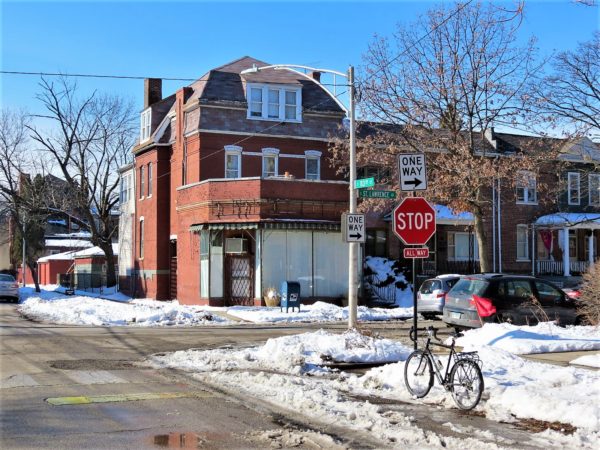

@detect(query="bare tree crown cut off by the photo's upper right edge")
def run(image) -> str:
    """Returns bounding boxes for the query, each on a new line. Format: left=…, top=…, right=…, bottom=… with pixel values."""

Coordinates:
left=537, top=31, right=600, bottom=133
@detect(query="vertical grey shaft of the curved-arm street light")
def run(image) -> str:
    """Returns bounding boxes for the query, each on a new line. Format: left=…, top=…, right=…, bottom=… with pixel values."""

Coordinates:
left=348, top=66, right=358, bottom=328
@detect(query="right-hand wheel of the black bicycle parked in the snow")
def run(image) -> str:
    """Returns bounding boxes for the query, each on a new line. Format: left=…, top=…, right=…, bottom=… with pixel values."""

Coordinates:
left=450, top=359, right=483, bottom=411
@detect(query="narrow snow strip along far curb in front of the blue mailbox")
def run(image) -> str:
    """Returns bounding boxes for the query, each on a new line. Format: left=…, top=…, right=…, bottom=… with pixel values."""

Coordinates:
left=227, top=302, right=412, bottom=323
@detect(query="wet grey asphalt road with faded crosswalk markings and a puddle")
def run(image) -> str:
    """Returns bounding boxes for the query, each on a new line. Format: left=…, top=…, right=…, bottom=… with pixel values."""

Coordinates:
left=0, top=302, right=552, bottom=449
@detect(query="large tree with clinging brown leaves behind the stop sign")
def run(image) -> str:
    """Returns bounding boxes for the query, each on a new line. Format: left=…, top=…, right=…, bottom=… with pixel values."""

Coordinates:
left=334, top=2, right=568, bottom=271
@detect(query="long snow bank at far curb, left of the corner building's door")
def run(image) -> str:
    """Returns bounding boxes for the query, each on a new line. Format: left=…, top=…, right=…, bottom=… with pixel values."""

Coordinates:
left=19, top=291, right=231, bottom=327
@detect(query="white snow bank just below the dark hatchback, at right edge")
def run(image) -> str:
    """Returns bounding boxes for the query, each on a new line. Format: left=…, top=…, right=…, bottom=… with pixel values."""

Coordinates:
left=456, top=322, right=600, bottom=355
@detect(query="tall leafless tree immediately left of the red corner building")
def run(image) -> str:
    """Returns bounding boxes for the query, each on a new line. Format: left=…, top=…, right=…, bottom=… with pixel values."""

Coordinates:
left=28, top=78, right=135, bottom=287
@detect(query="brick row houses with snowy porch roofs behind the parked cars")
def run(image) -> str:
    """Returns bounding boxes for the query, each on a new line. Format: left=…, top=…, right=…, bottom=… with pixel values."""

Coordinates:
left=359, top=130, right=600, bottom=277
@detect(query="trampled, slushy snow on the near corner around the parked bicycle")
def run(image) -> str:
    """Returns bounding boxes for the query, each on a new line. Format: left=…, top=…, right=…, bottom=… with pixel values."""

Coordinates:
left=150, top=325, right=600, bottom=449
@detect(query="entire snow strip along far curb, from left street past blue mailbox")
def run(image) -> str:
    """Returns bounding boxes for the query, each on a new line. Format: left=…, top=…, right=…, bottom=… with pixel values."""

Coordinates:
left=20, top=286, right=412, bottom=326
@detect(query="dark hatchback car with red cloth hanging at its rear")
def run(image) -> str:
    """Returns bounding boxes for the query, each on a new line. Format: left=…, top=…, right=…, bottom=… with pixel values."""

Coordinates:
left=442, top=274, right=579, bottom=328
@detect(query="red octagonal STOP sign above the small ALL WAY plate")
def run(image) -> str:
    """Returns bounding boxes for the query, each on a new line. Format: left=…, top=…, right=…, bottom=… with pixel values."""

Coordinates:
left=394, top=197, right=435, bottom=245
